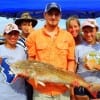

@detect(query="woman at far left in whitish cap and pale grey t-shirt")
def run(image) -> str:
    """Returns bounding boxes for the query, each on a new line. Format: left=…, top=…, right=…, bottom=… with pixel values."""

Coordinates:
left=0, top=23, right=26, bottom=100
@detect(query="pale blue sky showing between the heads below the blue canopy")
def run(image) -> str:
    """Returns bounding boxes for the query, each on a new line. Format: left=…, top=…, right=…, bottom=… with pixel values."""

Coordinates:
left=0, top=17, right=100, bottom=35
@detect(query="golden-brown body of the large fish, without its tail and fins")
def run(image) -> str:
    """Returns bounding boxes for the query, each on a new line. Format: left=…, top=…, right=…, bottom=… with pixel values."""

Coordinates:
left=11, top=60, right=90, bottom=87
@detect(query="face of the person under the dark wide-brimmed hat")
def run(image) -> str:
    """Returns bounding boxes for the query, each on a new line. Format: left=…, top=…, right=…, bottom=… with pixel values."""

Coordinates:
left=20, top=21, right=32, bottom=35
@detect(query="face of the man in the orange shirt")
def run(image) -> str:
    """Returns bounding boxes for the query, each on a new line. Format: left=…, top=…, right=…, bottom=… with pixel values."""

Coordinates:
left=44, top=9, right=61, bottom=27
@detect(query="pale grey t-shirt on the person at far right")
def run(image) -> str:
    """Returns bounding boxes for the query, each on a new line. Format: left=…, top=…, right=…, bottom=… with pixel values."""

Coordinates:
left=75, top=42, right=100, bottom=83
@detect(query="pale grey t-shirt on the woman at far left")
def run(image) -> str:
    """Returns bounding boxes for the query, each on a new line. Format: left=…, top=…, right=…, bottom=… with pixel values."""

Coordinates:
left=0, top=45, right=26, bottom=100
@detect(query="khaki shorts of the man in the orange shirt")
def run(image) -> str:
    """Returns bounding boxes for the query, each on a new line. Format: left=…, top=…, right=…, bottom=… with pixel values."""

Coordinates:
left=33, top=90, right=70, bottom=100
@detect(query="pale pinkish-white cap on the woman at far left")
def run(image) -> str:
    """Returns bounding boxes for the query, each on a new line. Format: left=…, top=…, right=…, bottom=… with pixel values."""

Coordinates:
left=4, top=23, right=20, bottom=34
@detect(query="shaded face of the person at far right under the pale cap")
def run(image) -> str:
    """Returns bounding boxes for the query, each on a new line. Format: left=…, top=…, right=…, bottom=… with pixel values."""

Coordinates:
left=83, top=26, right=97, bottom=44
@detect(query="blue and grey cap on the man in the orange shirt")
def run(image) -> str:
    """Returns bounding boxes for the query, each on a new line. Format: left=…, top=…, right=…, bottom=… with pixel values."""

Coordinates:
left=45, top=2, right=61, bottom=12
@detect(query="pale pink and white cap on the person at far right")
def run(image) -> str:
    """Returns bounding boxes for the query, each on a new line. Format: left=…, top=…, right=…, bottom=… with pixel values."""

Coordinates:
left=82, top=19, right=99, bottom=29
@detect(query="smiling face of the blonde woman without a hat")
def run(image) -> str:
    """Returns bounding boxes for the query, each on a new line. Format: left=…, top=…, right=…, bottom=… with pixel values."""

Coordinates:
left=68, top=20, right=80, bottom=37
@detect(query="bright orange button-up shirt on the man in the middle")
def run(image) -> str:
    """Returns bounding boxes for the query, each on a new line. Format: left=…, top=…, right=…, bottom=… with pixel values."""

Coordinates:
left=26, top=27, right=75, bottom=95
